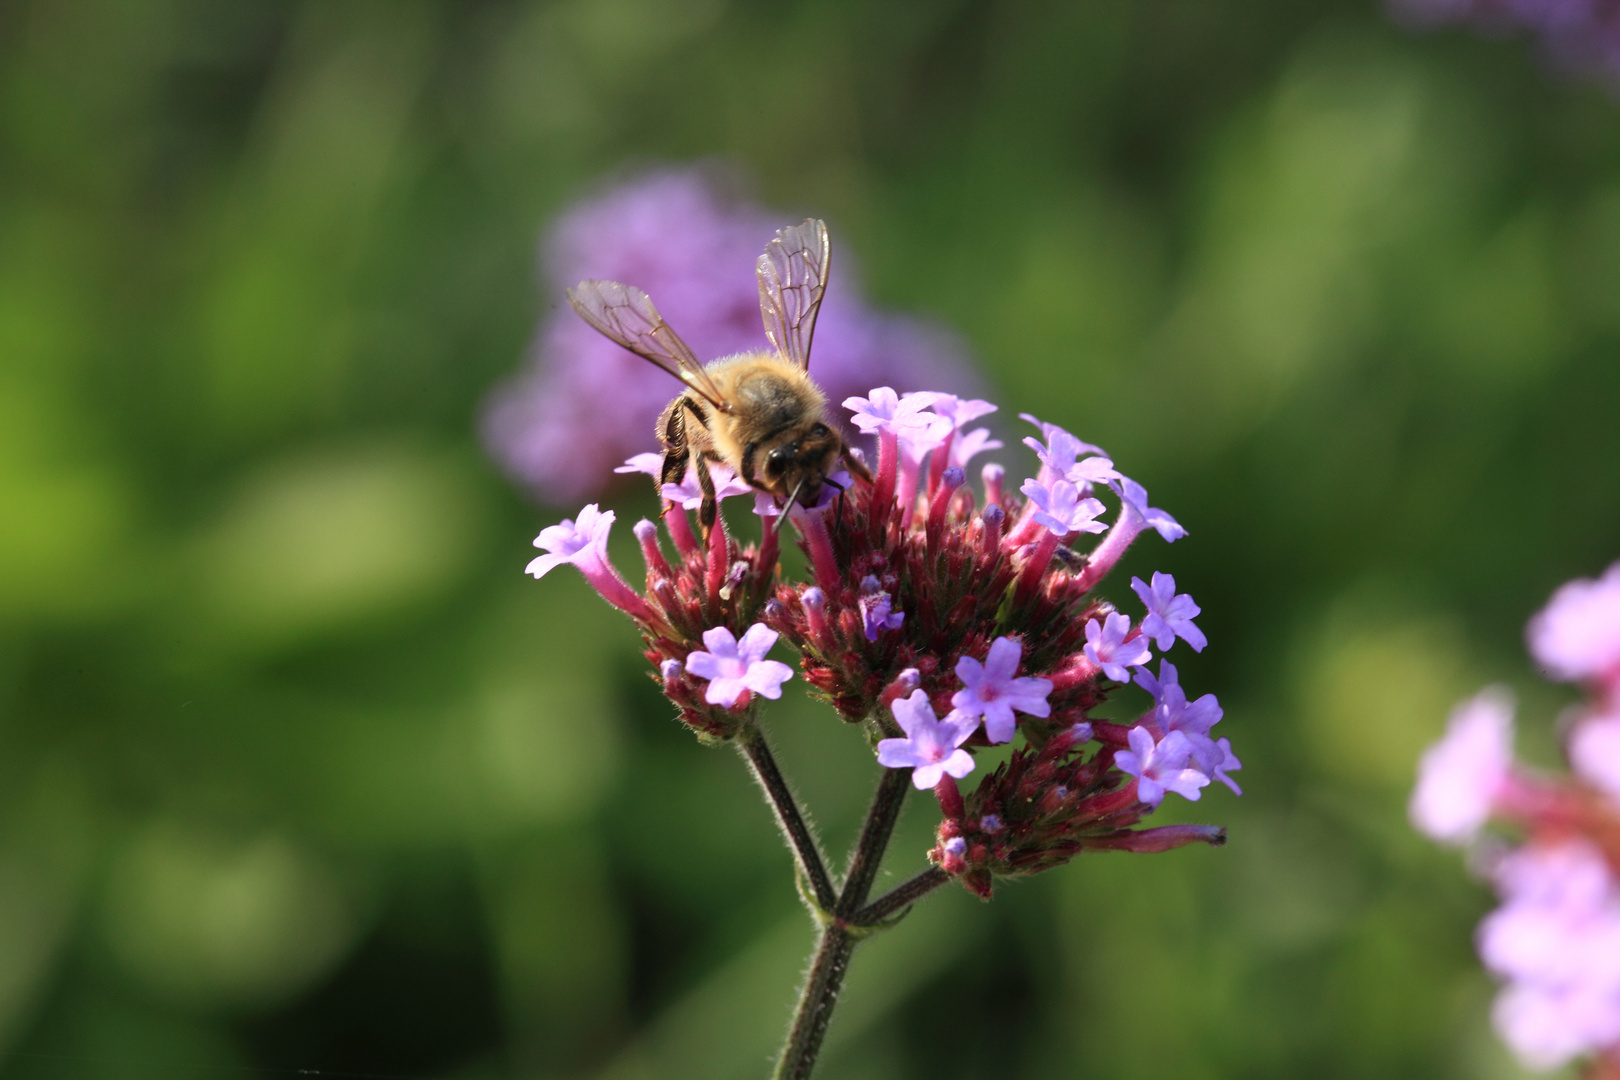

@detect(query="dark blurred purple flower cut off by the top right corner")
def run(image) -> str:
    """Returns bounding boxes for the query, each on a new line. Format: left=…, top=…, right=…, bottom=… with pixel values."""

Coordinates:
left=1390, top=0, right=1620, bottom=89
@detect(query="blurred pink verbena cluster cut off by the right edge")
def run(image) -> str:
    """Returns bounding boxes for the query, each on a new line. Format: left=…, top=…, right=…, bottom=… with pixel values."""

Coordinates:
left=1411, top=563, right=1620, bottom=1077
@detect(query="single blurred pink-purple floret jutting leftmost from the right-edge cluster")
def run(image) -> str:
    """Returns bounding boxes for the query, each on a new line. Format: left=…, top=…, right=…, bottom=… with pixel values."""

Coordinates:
left=1406, top=687, right=1513, bottom=844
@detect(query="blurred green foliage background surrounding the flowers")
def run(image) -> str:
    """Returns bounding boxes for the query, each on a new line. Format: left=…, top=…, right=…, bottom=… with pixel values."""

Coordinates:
left=0, top=0, right=1620, bottom=1080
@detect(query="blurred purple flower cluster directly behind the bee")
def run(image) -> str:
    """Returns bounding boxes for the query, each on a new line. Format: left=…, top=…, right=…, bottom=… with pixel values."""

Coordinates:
left=483, top=167, right=977, bottom=502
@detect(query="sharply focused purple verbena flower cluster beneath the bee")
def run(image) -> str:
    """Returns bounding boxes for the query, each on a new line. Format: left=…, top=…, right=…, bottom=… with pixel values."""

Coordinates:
left=528, top=388, right=1241, bottom=897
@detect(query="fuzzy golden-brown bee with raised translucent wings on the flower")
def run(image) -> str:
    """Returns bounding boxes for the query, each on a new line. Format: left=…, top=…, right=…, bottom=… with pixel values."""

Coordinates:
left=569, top=219, right=872, bottom=534
